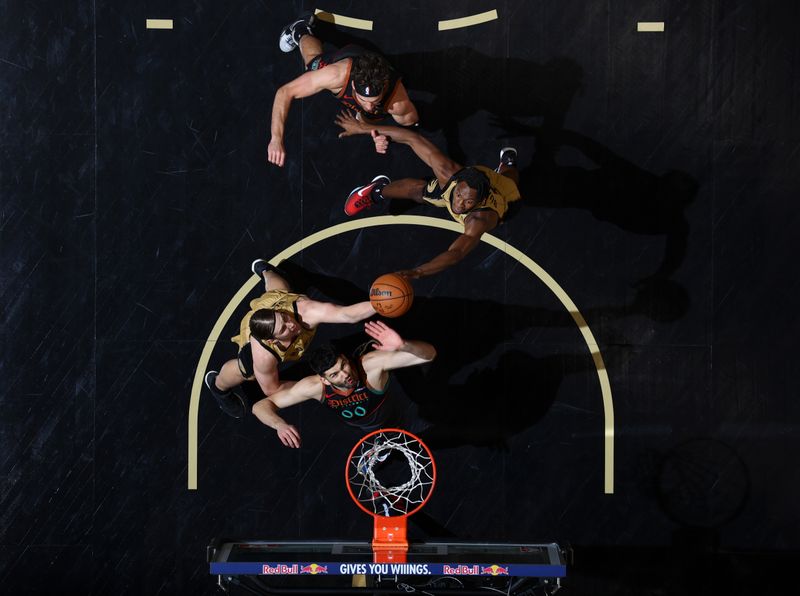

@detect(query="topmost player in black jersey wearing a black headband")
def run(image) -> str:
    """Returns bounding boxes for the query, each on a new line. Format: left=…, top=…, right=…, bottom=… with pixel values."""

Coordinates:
left=267, top=15, right=419, bottom=167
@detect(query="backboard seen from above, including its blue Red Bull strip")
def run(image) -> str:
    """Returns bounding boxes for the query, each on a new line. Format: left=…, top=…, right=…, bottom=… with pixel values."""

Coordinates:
left=207, top=540, right=566, bottom=594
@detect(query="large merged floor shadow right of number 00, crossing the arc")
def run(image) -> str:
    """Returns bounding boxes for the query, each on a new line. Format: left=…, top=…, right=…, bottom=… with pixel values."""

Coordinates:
left=396, top=280, right=690, bottom=448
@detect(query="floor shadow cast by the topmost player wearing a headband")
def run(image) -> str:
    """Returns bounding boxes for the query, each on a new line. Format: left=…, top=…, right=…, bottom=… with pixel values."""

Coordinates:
left=306, top=21, right=583, bottom=163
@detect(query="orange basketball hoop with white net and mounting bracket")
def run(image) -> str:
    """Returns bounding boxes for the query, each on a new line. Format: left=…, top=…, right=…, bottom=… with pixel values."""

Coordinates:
left=345, top=428, right=436, bottom=563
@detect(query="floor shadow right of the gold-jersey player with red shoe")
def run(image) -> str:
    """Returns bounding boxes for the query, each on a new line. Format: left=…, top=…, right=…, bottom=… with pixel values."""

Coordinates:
left=490, top=119, right=699, bottom=283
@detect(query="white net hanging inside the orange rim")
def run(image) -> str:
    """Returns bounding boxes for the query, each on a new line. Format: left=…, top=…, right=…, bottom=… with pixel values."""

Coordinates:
left=347, top=431, right=434, bottom=517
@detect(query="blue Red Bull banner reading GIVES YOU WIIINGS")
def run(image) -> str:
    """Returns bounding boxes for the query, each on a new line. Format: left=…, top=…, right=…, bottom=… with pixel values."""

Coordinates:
left=210, top=561, right=567, bottom=577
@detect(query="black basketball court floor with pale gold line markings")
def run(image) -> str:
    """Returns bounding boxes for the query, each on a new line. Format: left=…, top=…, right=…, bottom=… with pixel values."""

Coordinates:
left=0, top=0, right=800, bottom=595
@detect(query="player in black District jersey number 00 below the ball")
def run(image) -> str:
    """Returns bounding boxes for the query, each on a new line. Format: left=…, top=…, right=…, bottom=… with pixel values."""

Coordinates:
left=253, top=321, right=436, bottom=448
